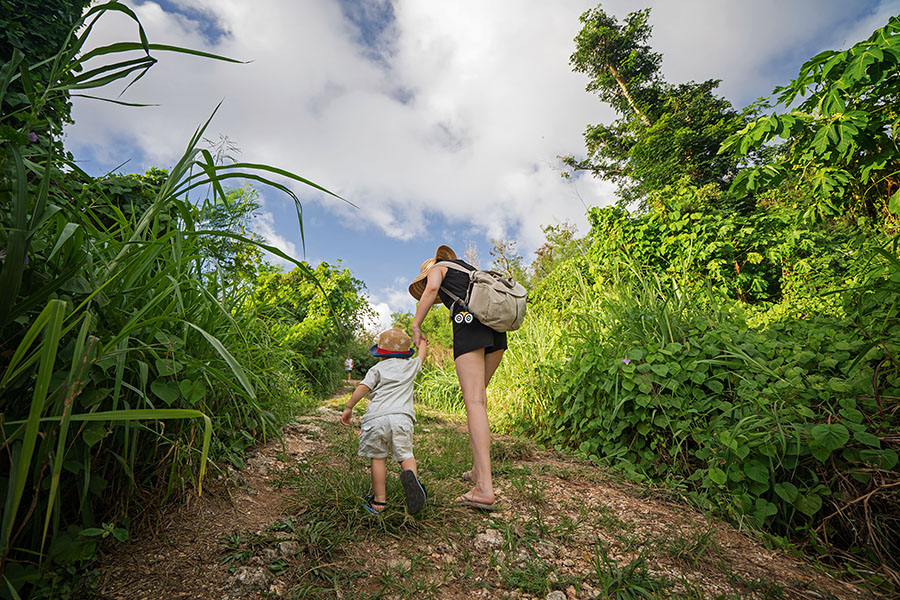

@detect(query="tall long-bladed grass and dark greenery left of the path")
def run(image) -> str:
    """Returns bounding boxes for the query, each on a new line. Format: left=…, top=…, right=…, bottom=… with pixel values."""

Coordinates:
left=0, top=2, right=348, bottom=596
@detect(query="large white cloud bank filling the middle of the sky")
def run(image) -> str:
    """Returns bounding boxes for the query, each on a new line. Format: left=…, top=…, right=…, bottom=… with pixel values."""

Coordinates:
left=70, top=0, right=610, bottom=251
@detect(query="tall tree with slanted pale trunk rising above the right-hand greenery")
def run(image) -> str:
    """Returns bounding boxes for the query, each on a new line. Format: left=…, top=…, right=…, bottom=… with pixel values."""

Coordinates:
left=563, top=6, right=745, bottom=205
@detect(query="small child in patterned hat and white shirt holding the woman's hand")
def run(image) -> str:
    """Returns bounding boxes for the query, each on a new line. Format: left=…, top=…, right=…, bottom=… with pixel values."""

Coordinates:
left=341, top=329, right=428, bottom=514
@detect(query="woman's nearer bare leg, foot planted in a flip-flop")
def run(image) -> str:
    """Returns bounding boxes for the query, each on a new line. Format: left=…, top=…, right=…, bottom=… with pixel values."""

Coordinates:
left=456, top=348, right=494, bottom=504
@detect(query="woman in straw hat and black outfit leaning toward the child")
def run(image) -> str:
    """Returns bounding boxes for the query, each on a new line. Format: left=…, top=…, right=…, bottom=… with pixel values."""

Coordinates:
left=409, top=246, right=506, bottom=510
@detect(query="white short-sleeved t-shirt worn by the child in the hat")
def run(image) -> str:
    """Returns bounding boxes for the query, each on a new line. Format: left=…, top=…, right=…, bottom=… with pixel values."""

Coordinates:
left=359, top=356, right=422, bottom=423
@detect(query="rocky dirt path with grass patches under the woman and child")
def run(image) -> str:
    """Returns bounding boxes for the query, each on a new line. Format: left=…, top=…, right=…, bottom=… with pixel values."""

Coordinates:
left=100, top=390, right=877, bottom=600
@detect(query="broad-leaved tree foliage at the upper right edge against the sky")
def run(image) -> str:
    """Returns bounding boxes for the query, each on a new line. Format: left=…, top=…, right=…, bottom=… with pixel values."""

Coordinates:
left=721, top=17, right=900, bottom=219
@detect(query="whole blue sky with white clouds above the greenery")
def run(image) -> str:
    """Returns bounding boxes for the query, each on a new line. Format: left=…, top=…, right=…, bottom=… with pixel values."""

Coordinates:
left=66, top=0, right=900, bottom=330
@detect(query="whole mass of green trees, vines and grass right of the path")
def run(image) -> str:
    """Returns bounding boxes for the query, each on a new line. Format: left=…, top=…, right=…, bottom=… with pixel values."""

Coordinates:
left=419, top=4, right=900, bottom=593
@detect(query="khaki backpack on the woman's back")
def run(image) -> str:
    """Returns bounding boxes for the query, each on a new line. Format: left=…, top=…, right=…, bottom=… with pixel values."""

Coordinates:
left=434, top=261, right=528, bottom=332
